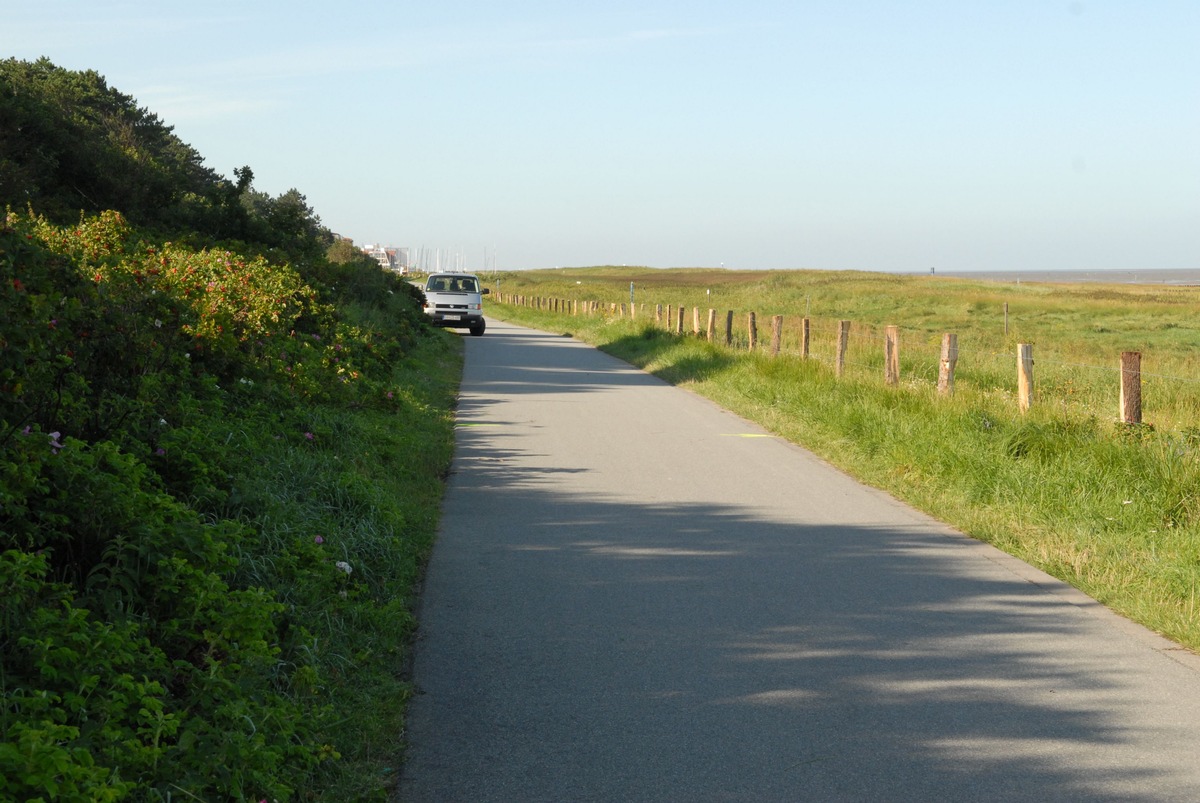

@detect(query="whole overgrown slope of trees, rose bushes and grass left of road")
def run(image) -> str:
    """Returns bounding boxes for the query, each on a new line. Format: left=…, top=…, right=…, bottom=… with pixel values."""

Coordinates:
left=0, top=60, right=461, bottom=802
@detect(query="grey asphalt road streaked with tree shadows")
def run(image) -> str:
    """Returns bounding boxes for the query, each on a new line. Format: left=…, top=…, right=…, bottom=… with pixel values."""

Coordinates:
left=400, top=322, right=1200, bottom=802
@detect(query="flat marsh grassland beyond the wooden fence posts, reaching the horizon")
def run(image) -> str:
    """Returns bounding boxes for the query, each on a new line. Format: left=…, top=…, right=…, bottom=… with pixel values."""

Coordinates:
left=482, top=268, right=1200, bottom=430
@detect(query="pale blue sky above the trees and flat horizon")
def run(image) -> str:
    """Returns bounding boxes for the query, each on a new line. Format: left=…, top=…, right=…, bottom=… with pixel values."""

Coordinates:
left=0, top=0, right=1200, bottom=271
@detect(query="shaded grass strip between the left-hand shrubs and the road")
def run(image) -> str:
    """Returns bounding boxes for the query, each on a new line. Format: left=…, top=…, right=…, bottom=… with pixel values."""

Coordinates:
left=225, top=332, right=462, bottom=801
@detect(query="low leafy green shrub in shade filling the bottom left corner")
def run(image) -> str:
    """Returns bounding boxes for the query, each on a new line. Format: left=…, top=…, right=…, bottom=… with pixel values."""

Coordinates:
left=0, top=433, right=316, bottom=799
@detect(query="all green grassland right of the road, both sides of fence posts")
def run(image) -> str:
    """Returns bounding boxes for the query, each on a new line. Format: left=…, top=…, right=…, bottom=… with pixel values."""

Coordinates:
left=487, top=268, right=1200, bottom=651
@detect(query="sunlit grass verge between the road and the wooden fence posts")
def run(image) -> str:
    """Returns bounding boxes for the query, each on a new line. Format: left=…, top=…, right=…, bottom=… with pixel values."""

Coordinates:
left=491, top=297, right=1200, bottom=651
